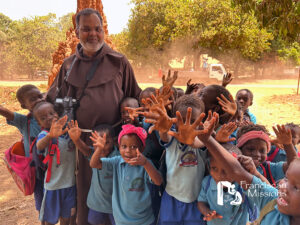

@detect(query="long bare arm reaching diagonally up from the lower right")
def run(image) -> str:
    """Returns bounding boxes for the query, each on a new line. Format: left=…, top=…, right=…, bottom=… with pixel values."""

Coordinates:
left=198, top=113, right=253, bottom=190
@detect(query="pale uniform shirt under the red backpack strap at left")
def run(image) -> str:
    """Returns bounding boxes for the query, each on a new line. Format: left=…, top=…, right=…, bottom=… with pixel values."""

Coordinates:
left=37, top=131, right=76, bottom=191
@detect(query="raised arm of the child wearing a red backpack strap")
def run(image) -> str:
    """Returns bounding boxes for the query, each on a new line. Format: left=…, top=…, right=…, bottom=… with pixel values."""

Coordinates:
left=36, top=115, right=68, bottom=150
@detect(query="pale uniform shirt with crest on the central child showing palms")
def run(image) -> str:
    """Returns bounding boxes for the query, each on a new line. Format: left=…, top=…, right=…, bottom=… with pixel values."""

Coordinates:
left=162, top=137, right=206, bottom=203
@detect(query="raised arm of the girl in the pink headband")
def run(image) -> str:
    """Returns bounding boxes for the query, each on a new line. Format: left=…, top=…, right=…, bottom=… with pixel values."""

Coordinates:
left=90, top=131, right=106, bottom=170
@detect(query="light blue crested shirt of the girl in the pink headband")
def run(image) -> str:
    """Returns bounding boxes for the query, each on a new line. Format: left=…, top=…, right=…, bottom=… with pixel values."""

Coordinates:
left=101, top=156, right=154, bottom=225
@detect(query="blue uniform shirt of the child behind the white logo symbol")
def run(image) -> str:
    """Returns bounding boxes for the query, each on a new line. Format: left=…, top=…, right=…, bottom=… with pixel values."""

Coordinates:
left=198, top=176, right=254, bottom=225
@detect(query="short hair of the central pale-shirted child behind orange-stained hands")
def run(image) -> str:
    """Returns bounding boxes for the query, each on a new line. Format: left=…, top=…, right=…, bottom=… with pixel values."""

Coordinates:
left=173, top=95, right=205, bottom=115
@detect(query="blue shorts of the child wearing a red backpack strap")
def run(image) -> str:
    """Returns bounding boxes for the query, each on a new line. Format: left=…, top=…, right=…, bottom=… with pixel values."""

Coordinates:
left=43, top=186, right=76, bottom=224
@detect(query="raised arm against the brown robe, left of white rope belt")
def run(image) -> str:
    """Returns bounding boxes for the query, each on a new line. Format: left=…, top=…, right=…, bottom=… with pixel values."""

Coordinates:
left=68, top=120, right=92, bottom=156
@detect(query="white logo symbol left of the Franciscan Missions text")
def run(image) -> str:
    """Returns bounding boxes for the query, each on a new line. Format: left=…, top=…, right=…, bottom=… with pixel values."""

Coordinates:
left=217, top=181, right=242, bottom=205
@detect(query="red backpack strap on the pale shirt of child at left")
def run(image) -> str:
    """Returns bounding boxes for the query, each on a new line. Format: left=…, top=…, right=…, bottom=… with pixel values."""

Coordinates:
left=43, top=131, right=60, bottom=183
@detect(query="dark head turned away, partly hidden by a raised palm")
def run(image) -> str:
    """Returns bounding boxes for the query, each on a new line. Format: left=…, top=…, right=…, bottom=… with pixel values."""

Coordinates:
left=198, top=84, right=230, bottom=124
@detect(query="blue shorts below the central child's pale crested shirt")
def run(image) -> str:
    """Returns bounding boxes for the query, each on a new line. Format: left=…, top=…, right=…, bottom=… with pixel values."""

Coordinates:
left=159, top=191, right=206, bottom=225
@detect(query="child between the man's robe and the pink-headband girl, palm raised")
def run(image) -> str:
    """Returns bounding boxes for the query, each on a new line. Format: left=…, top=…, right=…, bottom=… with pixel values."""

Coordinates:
left=68, top=120, right=119, bottom=225
